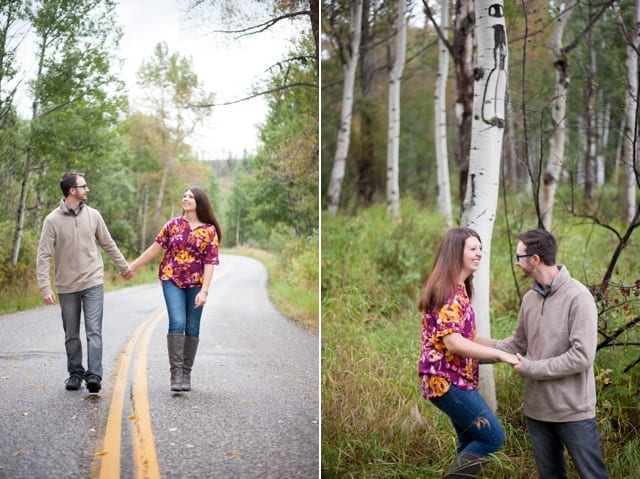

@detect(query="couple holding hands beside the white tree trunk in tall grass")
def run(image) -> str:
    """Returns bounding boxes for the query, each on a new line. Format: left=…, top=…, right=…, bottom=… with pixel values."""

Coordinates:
left=418, top=228, right=607, bottom=479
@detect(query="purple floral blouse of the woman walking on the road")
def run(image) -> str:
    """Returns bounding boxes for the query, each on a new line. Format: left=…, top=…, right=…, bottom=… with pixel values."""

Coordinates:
left=156, top=216, right=219, bottom=288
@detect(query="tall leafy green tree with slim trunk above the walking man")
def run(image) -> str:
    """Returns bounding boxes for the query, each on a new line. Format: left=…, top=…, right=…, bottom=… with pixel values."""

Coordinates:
left=11, top=0, right=121, bottom=266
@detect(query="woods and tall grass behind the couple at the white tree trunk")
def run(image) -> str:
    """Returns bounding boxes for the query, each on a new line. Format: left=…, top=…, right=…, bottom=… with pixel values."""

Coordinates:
left=321, top=0, right=640, bottom=479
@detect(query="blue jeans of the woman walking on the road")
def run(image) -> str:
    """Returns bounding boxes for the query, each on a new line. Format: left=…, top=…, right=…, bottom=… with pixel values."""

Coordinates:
left=162, top=280, right=202, bottom=338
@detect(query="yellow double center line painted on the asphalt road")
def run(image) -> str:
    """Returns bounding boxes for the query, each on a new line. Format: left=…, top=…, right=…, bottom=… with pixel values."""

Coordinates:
left=91, top=309, right=166, bottom=479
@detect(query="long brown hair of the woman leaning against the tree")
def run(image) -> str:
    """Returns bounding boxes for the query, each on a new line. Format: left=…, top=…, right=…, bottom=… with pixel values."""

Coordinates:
left=418, top=228, right=482, bottom=313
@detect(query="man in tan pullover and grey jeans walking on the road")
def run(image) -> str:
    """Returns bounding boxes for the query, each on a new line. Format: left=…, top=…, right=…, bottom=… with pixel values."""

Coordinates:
left=36, top=172, right=133, bottom=393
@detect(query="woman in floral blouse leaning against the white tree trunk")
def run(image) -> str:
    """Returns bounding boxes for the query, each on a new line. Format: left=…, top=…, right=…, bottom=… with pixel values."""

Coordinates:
left=418, top=228, right=518, bottom=478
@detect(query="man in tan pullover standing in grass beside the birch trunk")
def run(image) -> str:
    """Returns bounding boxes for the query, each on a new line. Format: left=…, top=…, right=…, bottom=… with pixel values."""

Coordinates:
left=494, top=229, right=607, bottom=479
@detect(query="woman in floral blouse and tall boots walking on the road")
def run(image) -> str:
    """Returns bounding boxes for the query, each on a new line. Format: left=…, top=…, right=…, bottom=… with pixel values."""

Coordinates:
left=130, top=188, right=222, bottom=391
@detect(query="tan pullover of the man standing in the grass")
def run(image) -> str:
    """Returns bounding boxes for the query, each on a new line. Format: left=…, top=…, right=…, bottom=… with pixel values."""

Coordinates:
left=496, top=266, right=598, bottom=422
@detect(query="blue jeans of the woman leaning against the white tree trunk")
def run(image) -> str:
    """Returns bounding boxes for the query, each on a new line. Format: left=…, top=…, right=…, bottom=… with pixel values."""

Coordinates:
left=431, top=385, right=504, bottom=457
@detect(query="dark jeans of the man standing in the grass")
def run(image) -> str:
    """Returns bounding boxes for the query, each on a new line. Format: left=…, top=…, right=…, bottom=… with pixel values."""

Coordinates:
left=527, top=417, right=607, bottom=479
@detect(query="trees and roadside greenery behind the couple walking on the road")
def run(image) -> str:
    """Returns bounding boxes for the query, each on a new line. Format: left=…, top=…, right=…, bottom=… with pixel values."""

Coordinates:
left=0, top=0, right=319, bottom=330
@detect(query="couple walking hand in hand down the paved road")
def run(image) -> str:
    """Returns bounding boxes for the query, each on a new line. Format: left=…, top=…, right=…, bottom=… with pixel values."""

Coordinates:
left=36, top=172, right=221, bottom=393
